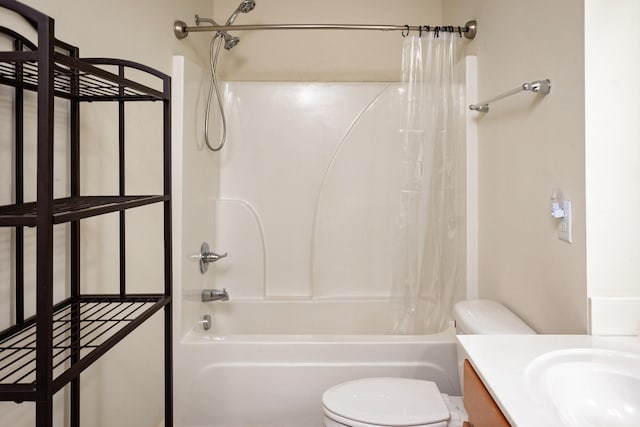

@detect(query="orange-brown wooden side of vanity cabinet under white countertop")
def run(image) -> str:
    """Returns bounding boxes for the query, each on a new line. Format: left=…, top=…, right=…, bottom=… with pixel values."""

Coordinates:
left=463, top=360, right=511, bottom=427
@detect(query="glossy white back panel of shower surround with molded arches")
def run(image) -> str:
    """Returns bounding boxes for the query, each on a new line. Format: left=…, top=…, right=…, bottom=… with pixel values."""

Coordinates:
left=213, top=82, right=402, bottom=298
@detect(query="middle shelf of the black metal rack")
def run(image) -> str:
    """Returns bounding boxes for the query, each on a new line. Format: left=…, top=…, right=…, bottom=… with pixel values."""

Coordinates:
left=0, top=196, right=169, bottom=227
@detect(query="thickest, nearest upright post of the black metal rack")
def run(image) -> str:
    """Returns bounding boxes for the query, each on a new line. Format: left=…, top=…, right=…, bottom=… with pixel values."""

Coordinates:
left=36, top=15, right=55, bottom=427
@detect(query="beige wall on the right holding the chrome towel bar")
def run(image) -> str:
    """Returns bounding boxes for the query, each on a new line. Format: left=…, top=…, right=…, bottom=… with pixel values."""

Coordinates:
left=443, top=0, right=587, bottom=333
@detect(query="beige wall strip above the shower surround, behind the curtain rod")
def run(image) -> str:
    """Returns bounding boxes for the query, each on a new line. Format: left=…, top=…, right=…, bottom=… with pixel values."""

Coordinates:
left=210, top=0, right=441, bottom=81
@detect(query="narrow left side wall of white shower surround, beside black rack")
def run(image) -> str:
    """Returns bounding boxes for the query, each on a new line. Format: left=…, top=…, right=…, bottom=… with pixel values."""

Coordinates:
left=172, top=56, right=219, bottom=338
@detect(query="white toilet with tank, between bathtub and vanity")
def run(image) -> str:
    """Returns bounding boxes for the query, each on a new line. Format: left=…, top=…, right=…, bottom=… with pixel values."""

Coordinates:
left=322, top=300, right=535, bottom=427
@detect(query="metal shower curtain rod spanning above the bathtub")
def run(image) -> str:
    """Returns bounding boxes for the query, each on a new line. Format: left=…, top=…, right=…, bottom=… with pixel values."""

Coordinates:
left=173, top=21, right=478, bottom=40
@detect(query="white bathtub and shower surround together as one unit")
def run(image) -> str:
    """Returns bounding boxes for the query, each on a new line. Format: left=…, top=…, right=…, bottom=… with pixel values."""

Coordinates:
left=173, top=58, right=468, bottom=427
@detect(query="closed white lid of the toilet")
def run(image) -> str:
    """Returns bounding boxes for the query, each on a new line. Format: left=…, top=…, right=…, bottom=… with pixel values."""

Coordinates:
left=322, top=378, right=449, bottom=426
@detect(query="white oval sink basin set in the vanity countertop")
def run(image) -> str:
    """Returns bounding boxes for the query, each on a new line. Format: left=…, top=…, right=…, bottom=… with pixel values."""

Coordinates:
left=525, top=348, right=640, bottom=427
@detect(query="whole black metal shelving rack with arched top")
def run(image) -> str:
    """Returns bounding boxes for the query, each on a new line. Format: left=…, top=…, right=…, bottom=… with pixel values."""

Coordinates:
left=0, top=0, right=173, bottom=427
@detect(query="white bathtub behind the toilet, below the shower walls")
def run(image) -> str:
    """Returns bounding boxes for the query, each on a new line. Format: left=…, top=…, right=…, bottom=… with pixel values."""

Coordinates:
left=175, top=300, right=460, bottom=427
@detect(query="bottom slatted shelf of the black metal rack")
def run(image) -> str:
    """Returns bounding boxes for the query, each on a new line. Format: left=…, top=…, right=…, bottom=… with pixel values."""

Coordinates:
left=0, top=295, right=170, bottom=401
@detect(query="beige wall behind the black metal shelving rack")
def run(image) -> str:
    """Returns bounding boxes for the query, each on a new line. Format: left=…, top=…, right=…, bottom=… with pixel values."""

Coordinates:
left=0, top=0, right=212, bottom=427
